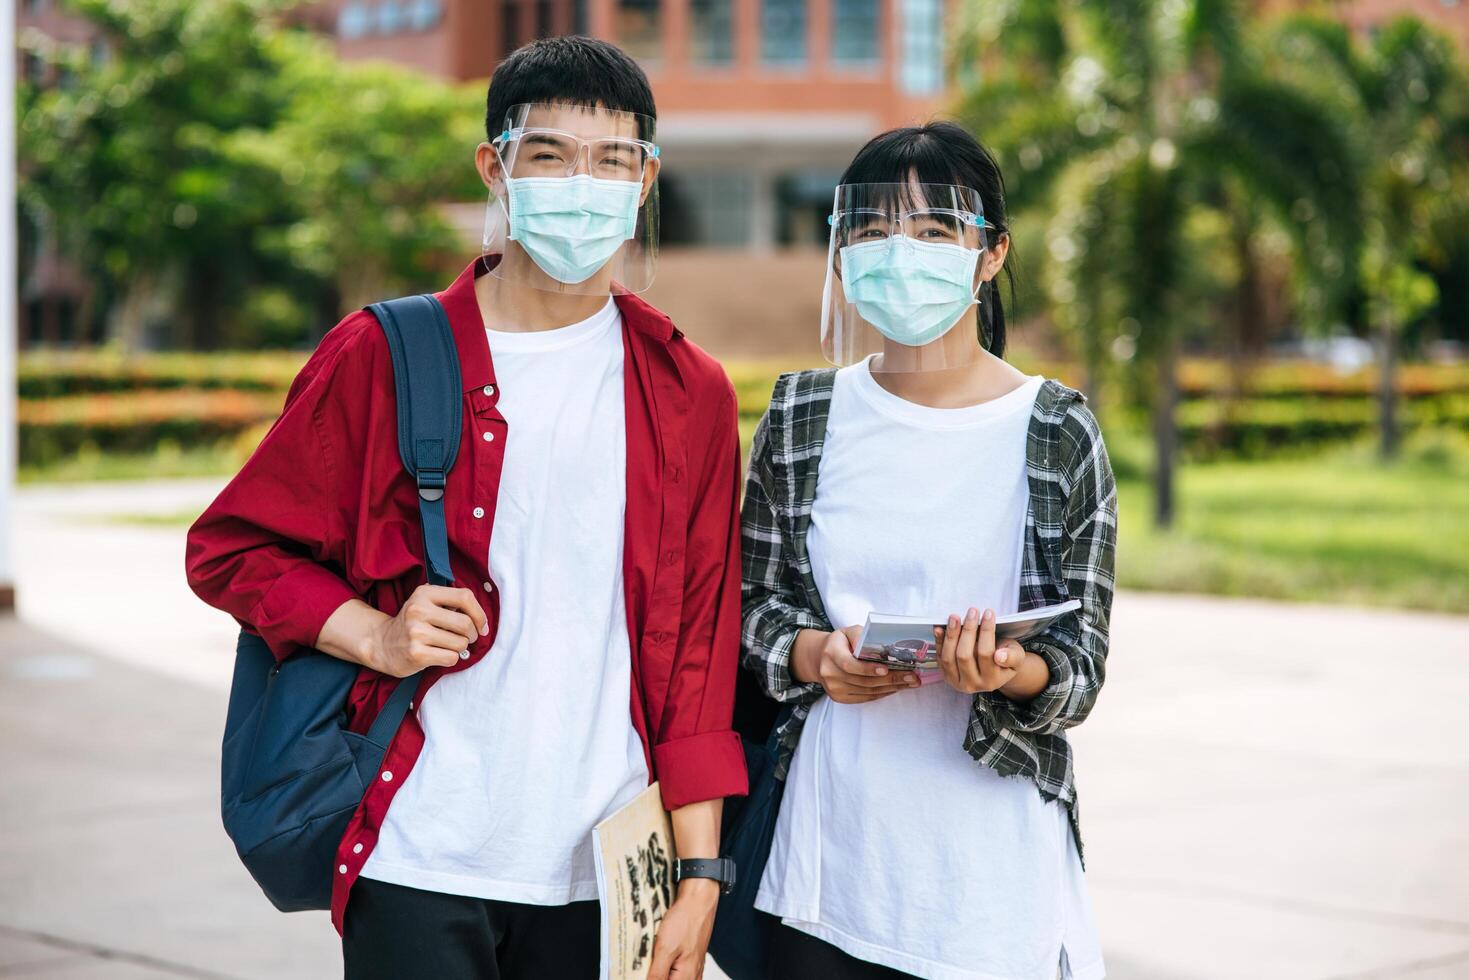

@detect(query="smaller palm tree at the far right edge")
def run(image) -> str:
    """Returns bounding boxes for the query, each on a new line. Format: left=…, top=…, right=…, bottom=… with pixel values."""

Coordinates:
left=1275, top=15, right=1469, bottom=458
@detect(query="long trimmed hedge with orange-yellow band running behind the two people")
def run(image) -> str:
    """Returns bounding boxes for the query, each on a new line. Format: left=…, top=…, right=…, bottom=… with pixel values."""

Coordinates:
left=19, top=351, right=1469, bottom=466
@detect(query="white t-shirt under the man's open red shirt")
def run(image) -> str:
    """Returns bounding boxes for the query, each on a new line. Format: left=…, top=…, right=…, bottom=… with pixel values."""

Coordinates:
left=363, top=300, right=648, bottom=905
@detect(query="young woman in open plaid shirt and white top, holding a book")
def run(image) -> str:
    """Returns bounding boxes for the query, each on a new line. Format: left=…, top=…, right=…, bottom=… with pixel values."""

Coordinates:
left=743, top=123, right=1116, bottom=980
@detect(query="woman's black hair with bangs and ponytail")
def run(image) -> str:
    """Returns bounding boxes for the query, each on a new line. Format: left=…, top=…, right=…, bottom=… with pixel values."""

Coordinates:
left=842, top=122, right=1015, bottom=357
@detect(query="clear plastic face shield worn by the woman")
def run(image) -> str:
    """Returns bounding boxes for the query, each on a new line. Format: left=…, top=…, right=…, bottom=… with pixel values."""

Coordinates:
left=821, top=182, right=997, bottom=372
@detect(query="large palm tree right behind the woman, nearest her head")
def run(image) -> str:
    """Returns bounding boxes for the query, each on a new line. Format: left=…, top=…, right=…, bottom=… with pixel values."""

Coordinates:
left=956, top=0, right=1359, bottom=527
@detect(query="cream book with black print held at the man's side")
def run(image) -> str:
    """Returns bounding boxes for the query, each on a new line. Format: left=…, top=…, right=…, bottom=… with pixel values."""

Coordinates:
left=592, top=783, right=677, bottom=980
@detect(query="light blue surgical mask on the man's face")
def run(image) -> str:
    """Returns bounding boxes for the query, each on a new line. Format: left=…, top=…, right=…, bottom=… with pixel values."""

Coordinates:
left=505, top=173, right=642, bottom=284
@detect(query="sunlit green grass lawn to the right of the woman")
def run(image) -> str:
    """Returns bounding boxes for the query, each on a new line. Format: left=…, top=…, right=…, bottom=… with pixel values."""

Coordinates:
left=1118, top=436, right=1469, bottom=613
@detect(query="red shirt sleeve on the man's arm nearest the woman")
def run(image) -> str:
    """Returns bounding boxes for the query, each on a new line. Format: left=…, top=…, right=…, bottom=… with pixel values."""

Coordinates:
left=652, top=379, right=748, bottom=810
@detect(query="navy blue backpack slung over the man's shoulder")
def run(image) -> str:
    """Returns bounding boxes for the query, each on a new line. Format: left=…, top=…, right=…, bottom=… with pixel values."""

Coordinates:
left=220, top=295, right=461, bottom=912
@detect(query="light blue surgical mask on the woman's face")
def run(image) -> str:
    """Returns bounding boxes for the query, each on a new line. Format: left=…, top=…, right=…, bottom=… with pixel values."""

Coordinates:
left=842, top=235, right=980, bottom=347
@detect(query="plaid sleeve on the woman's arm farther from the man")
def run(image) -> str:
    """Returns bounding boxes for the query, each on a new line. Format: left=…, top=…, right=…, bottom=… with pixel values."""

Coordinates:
left=978, top=404, right=1116, bottom=735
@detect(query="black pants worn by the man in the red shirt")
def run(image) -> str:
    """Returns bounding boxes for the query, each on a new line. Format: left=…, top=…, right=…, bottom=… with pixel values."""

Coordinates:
left=342, top=879, right=602, bottom=980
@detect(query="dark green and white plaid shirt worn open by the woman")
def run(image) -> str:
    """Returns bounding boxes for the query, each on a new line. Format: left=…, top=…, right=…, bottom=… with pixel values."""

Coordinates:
left=742, top=369, right=1116, bottom=851
